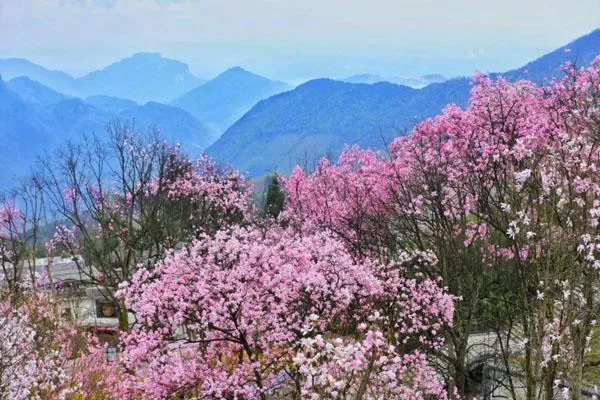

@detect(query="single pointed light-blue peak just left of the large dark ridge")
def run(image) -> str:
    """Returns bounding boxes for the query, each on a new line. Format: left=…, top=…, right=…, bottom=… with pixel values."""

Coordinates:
left=172, top=67, right=289, bottom=131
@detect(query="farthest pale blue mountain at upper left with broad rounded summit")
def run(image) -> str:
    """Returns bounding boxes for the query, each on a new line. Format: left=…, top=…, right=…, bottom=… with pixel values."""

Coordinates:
left=0, top=53, right=206, bottom=103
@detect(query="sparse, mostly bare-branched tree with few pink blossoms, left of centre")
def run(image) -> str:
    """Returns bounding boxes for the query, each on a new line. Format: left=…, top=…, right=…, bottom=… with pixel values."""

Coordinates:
left=37, top=121, right=250, bottom=330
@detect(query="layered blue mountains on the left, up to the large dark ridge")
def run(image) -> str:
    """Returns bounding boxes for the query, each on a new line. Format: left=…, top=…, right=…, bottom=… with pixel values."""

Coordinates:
left=0, top=53, right=296, bottom=188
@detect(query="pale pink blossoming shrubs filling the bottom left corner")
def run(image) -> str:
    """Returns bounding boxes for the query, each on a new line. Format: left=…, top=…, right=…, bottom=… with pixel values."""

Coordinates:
left=0, top=291, right=130, bottom=400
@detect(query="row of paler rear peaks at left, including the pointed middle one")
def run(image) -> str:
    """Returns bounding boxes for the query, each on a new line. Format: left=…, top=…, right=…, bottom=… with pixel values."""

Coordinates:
left=0, top=53, right=290, bottom=133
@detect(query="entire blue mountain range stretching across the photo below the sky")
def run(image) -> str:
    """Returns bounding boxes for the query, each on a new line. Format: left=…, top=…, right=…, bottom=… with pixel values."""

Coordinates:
left=0, top=29, right=600, bottom=187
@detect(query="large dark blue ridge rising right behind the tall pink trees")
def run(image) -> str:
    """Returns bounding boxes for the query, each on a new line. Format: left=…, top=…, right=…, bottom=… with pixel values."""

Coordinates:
left=207, top=30, right=600, bottom=176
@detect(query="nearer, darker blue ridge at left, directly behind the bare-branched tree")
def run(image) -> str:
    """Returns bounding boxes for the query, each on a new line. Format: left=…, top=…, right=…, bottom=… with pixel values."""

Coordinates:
left=0, top=77, right=218, bottom=189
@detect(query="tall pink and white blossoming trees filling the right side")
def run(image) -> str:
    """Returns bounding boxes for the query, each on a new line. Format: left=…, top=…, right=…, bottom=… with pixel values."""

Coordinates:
left=285, top=59, right=600, bottom=399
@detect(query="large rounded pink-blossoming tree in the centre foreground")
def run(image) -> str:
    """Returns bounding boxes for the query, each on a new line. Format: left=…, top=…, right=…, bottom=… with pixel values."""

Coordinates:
left=122, top=227, right=453, bottom=398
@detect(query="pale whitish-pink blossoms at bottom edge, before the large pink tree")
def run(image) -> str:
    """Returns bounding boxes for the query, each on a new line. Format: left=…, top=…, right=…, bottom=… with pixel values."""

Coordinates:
left=294, top=330, right=448, bottom=400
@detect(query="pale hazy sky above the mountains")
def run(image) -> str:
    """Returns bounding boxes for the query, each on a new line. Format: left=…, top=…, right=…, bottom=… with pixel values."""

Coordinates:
left=0, top=0, right=600, bottom=81
